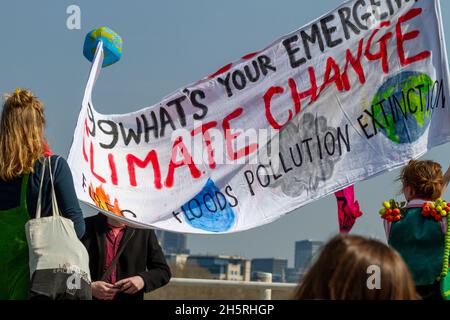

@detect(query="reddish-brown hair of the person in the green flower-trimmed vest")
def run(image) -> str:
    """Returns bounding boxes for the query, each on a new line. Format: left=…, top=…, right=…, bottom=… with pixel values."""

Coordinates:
left=400, top=160, right=444, bottom=201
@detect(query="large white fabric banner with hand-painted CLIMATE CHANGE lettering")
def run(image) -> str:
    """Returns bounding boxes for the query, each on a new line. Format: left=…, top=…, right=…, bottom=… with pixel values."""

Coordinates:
left=68, top=0, right=450, bottom=233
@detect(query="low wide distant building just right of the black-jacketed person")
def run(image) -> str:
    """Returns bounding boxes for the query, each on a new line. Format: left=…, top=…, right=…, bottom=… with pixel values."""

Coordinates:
left=186, top=255, right=251, bottom=281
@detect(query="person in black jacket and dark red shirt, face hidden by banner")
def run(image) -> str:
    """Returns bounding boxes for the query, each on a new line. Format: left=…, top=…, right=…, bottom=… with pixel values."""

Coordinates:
left=82, top=213, right=171, bottom=300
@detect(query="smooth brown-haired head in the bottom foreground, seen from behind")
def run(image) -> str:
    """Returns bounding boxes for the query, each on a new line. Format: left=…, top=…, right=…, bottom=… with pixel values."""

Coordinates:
left=295, top=235, right=418, bottom=300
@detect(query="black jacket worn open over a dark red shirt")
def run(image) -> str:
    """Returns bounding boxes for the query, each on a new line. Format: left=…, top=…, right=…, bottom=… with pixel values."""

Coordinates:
left=82, top=214, right=171, bottom=300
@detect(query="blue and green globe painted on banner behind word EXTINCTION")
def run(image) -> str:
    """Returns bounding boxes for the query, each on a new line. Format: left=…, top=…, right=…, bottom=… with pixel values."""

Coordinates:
left=372, top=71, right=434, bottom=144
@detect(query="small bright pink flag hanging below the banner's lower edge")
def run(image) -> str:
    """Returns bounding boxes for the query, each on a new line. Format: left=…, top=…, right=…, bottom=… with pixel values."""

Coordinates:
left=334, top=185, right=362, bottom=233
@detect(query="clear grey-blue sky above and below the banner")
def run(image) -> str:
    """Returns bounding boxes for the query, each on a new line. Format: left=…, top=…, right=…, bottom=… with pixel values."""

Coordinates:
left=0, top=0, right=450, bottom=263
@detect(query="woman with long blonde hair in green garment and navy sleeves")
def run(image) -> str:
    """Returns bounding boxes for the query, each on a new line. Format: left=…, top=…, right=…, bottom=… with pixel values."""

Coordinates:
left=0, top=89, right=85, bottom=300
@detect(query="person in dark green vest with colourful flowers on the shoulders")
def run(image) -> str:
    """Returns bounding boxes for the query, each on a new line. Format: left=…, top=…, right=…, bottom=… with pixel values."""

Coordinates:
left=380, top=160, right=450, bottom=299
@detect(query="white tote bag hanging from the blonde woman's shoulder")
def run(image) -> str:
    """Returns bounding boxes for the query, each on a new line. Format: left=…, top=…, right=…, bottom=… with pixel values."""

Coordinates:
left=25, top=158, right=92, bottom=300
